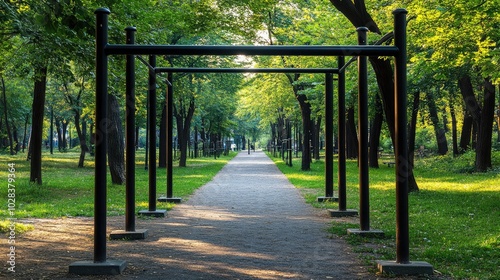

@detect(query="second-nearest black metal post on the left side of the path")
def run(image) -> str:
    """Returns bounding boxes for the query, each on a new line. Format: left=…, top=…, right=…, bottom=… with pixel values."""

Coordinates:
left=125, top=27, right=137, bottom=231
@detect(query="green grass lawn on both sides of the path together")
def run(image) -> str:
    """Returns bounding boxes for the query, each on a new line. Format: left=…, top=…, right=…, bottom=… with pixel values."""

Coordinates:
left=0, top=149, right=500, bottom=279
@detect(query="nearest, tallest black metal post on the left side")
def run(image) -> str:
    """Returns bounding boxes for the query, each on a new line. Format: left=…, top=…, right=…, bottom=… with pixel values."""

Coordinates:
left=94, top=8, right=110, bottom=263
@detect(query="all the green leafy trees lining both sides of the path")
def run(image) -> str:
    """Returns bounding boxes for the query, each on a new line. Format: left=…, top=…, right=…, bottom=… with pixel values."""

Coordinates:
left=0, top=0, right=500, bottom=189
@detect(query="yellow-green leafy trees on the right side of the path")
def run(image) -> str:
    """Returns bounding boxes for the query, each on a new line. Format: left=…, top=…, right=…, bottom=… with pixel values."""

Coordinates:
left=236, top=0, right=500, bottom=180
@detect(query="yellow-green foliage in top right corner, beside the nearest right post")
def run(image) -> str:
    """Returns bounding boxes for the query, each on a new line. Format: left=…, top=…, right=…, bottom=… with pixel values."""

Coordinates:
left=408, top=1, right=500, bottom=83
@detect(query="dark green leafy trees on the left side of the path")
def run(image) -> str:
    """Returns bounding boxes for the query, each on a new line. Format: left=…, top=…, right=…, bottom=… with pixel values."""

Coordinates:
left=0, top=0, right=270, bottom=184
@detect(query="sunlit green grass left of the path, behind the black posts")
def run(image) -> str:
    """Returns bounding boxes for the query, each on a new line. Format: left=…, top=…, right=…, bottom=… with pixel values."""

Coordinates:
left=0, top=152, right=237, bottom=234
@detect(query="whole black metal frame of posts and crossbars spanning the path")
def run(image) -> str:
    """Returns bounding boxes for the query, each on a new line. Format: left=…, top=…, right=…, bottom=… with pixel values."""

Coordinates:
left=70, top=8, right=428, bottom=276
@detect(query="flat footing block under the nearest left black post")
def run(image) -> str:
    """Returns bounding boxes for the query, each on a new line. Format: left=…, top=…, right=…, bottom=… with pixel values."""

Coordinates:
left=69, top=260, right=127, bottom=275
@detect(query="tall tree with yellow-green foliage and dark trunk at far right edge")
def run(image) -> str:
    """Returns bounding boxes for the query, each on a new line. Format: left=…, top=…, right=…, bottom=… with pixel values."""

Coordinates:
left=409, top=0, right=500, bottom=171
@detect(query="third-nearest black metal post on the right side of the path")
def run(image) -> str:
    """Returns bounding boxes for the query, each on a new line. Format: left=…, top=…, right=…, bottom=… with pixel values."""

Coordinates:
left=338, top=56, right=347, bottom=211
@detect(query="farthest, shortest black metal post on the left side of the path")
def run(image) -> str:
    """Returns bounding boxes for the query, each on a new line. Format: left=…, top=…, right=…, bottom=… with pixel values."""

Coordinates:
left=166, top=72, right=174, bottom=198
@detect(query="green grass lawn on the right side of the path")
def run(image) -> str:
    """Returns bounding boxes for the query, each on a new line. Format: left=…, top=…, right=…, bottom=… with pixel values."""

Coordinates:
left=275, top=152, right=500, bottom=279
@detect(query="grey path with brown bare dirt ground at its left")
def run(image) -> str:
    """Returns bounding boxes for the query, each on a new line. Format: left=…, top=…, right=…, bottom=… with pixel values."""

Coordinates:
left=0, top=152, right=375, bottom=279
